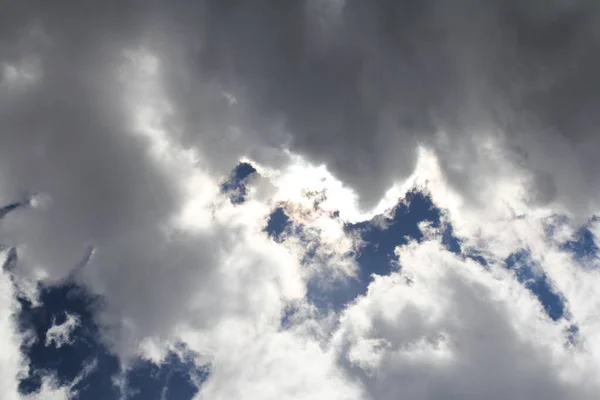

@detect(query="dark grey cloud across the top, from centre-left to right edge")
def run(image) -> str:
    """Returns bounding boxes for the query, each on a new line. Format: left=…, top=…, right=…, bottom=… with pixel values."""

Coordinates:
left=150, top=0, right=599, bottom=211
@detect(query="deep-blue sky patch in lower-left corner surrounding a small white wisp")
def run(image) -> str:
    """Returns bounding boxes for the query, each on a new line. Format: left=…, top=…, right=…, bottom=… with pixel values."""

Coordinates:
left=19, top=282, right=119, bottom=399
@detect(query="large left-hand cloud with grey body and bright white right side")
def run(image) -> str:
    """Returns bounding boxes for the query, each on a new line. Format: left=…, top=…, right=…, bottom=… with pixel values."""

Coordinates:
left=0, top=11, right=303, bottom=368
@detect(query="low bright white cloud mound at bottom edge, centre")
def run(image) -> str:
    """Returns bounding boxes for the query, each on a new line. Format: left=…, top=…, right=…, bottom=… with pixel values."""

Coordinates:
left=190, top=332, right=361, bottom=400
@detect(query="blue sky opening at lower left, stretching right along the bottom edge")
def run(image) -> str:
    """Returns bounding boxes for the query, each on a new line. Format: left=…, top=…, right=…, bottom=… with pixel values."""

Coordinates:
left=14, top=276, right=208, bottom=400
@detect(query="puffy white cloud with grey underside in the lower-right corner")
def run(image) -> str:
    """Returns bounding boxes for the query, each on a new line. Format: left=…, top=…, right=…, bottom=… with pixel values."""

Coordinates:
left=333, top=240, right=600, bottom=399
